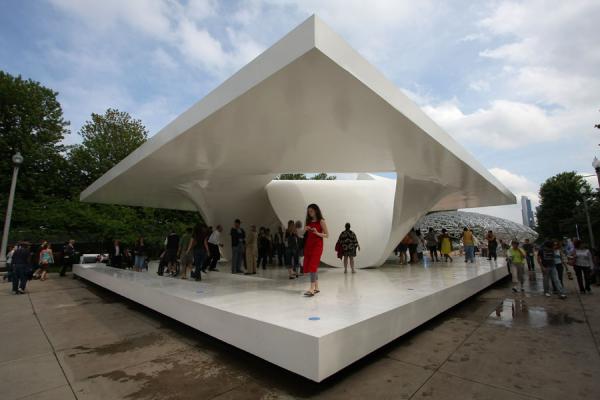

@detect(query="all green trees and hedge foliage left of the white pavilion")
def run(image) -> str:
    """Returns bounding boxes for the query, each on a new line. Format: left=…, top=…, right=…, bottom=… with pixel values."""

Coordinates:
left=0, top=71, right=200, bottom=255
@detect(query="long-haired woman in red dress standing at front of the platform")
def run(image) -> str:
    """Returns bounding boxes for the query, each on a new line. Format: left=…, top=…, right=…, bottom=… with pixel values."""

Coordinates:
left=304, top=204, right=329, bottom=297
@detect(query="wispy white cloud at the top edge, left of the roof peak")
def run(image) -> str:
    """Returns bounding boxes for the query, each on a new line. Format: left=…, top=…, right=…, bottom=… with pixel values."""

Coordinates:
left=50, top=0, right=264, bottom=78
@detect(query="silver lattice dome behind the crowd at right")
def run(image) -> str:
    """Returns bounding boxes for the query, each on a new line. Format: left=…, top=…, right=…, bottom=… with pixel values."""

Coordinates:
left=415, top=211, right=538, bottom=242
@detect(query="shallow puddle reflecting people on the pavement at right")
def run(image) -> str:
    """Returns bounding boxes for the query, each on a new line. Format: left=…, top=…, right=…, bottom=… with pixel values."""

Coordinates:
left=487, top=299, right=583, bottom=328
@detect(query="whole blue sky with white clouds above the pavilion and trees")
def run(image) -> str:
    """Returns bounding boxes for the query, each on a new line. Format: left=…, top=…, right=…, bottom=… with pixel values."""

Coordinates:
left=0, top=0, right=600, bottom=222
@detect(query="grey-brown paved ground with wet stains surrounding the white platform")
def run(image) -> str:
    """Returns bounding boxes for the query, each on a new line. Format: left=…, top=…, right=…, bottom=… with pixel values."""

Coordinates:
left=0, top=266, right=600, bottom=400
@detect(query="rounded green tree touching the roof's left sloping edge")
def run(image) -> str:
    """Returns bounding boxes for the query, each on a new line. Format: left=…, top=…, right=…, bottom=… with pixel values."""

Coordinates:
left=70, top=108, right=148, bottom=191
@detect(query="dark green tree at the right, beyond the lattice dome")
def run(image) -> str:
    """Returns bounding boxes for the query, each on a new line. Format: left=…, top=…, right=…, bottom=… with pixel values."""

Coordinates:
left=537, top=172, right=593, bottom=238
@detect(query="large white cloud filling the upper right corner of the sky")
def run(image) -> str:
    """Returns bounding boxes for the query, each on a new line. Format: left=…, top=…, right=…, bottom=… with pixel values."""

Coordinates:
left=479, top=0, right=600, bottom=108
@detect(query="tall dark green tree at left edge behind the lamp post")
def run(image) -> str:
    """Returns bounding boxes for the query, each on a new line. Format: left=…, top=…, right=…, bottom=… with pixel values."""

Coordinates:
left=0, top=71, right=69, bottom=199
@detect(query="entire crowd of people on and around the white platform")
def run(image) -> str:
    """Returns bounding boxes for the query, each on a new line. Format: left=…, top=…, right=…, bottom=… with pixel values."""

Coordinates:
left=5, top=208, right=600, bottom=298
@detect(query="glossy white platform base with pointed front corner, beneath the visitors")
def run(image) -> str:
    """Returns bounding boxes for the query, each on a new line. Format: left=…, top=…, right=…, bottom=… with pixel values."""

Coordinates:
left=73, top=260, right=507, bottom=382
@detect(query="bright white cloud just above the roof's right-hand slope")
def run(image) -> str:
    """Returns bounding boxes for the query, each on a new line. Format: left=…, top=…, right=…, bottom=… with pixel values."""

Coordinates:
left=423, top=100, right=559, bottom=149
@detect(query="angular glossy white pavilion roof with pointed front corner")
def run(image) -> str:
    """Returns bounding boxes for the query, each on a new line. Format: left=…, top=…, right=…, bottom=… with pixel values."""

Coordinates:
left=81, top=16, right=516, bottom=212
